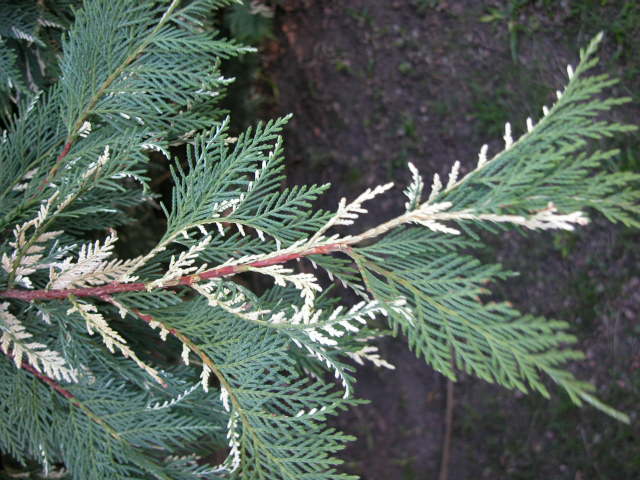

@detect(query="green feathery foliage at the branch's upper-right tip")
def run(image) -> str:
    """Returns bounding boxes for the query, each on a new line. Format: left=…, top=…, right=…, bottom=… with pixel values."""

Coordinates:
left=441, top=52, right=640, bottom=227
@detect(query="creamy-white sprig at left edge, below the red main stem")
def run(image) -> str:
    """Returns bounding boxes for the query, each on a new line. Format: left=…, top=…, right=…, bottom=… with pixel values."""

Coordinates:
left=0, top=302, right=78, bottom=382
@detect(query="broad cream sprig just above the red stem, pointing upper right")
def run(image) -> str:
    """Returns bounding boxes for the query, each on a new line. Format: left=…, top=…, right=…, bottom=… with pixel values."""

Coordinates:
left=47, top=232, right=137, bottom=290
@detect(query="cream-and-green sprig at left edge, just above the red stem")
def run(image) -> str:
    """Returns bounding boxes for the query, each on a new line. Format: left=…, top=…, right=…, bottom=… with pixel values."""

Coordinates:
left=2, top=193, right=62, bottom=288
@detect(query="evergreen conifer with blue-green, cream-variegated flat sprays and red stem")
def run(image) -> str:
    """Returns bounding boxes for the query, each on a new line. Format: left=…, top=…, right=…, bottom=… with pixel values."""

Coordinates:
left=0, top=0, right=640, bottom=480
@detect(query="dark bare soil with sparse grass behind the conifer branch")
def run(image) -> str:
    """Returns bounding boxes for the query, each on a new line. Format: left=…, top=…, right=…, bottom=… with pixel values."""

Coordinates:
left=262, top=0, right=640, bottom=480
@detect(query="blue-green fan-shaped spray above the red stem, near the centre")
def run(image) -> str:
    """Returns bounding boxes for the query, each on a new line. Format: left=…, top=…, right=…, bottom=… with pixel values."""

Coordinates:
left=167, top=117, right=328, bottom=248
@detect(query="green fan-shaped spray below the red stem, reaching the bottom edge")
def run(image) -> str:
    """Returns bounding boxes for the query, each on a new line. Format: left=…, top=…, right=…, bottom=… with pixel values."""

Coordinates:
left=156, top=300, right=352, bottom=480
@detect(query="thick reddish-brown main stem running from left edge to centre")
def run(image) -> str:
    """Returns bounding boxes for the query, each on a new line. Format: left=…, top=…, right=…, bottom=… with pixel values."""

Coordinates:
left=0, top=243, right=349, bottom=302
